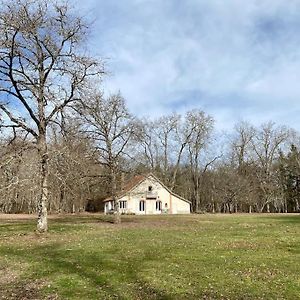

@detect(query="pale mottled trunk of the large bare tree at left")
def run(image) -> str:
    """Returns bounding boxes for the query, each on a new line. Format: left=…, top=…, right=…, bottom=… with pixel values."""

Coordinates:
left=37, top=135, right=48, bottom=232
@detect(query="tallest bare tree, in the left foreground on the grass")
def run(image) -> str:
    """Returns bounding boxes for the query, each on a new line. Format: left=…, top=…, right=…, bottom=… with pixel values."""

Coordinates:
left=0, top=0, right=103, bottom=232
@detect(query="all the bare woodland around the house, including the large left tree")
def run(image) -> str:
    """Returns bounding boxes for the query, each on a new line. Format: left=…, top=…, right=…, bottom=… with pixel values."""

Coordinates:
left=0, top=1, right=300, bottom=231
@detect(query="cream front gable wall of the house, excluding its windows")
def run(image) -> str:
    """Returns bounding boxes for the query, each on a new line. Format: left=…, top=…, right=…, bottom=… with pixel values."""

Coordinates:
left=115, top=177, right=190, bottom=215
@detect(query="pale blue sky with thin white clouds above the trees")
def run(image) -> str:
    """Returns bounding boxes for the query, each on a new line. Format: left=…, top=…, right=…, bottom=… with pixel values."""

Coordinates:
left=74, top=0, right=300, bottom=130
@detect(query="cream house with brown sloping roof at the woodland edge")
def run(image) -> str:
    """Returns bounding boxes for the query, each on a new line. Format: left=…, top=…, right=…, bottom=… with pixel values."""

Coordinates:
left=104, top=174, right=191, bottom=215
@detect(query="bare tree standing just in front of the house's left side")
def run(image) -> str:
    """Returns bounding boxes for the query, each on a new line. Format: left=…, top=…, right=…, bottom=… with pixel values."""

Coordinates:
left=78, top=93, right=135, bottom=223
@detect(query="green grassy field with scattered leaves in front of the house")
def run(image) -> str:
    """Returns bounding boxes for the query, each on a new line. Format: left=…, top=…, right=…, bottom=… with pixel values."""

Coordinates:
left=0, top=214, right=300, bottom=300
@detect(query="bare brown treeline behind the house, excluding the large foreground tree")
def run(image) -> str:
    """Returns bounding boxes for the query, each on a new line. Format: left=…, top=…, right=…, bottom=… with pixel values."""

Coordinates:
left=0, top=95, right=300, bottom=213
